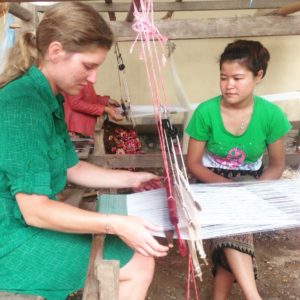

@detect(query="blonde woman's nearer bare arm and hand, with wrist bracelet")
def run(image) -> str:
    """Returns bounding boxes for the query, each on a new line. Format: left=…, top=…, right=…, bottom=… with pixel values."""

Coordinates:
left=16, top=193, right=168, bottom=256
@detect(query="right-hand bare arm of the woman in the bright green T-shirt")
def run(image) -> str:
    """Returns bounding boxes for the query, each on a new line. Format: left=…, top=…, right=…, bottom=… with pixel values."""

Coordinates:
left=259, top=137, right=285, bottom=180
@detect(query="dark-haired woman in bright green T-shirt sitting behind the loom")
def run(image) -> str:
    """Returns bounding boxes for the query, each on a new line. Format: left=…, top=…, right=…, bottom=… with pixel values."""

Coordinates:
left=186, top=40, right=291, bottom=300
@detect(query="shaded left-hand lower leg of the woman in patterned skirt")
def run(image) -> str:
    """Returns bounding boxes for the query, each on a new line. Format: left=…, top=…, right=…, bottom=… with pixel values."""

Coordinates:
left=213, top=266, right=234, bottom=300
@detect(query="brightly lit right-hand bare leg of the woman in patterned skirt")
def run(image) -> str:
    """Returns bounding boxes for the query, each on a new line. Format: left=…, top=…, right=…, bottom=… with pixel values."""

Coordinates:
left=223, top=248, right=261, bottom=300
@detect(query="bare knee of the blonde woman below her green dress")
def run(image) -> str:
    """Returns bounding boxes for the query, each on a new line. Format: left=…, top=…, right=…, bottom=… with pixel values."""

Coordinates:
left=119, top=252, right=155, bottom=300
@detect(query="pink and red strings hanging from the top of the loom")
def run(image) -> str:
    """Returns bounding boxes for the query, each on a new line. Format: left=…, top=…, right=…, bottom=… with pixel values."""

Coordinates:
left=130, top=1, right=186, bottom=256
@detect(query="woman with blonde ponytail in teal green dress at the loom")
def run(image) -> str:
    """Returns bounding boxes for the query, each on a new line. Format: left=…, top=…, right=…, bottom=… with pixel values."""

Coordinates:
left=0, top=2, right=168, bottom=300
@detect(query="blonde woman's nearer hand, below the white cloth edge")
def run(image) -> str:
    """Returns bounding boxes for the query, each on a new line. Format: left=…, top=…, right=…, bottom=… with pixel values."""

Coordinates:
left=107, top=215, right=169, bottom=257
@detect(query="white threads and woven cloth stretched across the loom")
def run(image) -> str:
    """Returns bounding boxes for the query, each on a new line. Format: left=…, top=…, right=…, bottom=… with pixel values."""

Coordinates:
left=98, top=178, right=300, bottom=239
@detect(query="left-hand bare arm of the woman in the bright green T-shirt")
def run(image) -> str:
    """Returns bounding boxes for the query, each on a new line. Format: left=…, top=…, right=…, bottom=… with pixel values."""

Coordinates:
left=186, top=138, right=230, bottom=183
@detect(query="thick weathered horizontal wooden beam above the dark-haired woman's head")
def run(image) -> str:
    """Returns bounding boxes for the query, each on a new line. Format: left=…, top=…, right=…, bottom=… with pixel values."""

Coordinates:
left=110, top=16, right=300, bottom=41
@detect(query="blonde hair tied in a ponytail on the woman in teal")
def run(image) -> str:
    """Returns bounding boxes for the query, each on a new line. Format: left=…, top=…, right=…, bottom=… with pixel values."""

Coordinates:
left=0, top=2, right=113, bottom=88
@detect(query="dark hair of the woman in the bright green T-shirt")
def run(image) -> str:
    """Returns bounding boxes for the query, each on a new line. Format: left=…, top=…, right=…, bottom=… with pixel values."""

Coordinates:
left=219, top=40, right=270, bottom=77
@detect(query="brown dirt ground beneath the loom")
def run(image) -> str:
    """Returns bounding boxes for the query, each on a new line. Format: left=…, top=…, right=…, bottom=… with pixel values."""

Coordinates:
left=147, top=228, right=300, bottom=300
